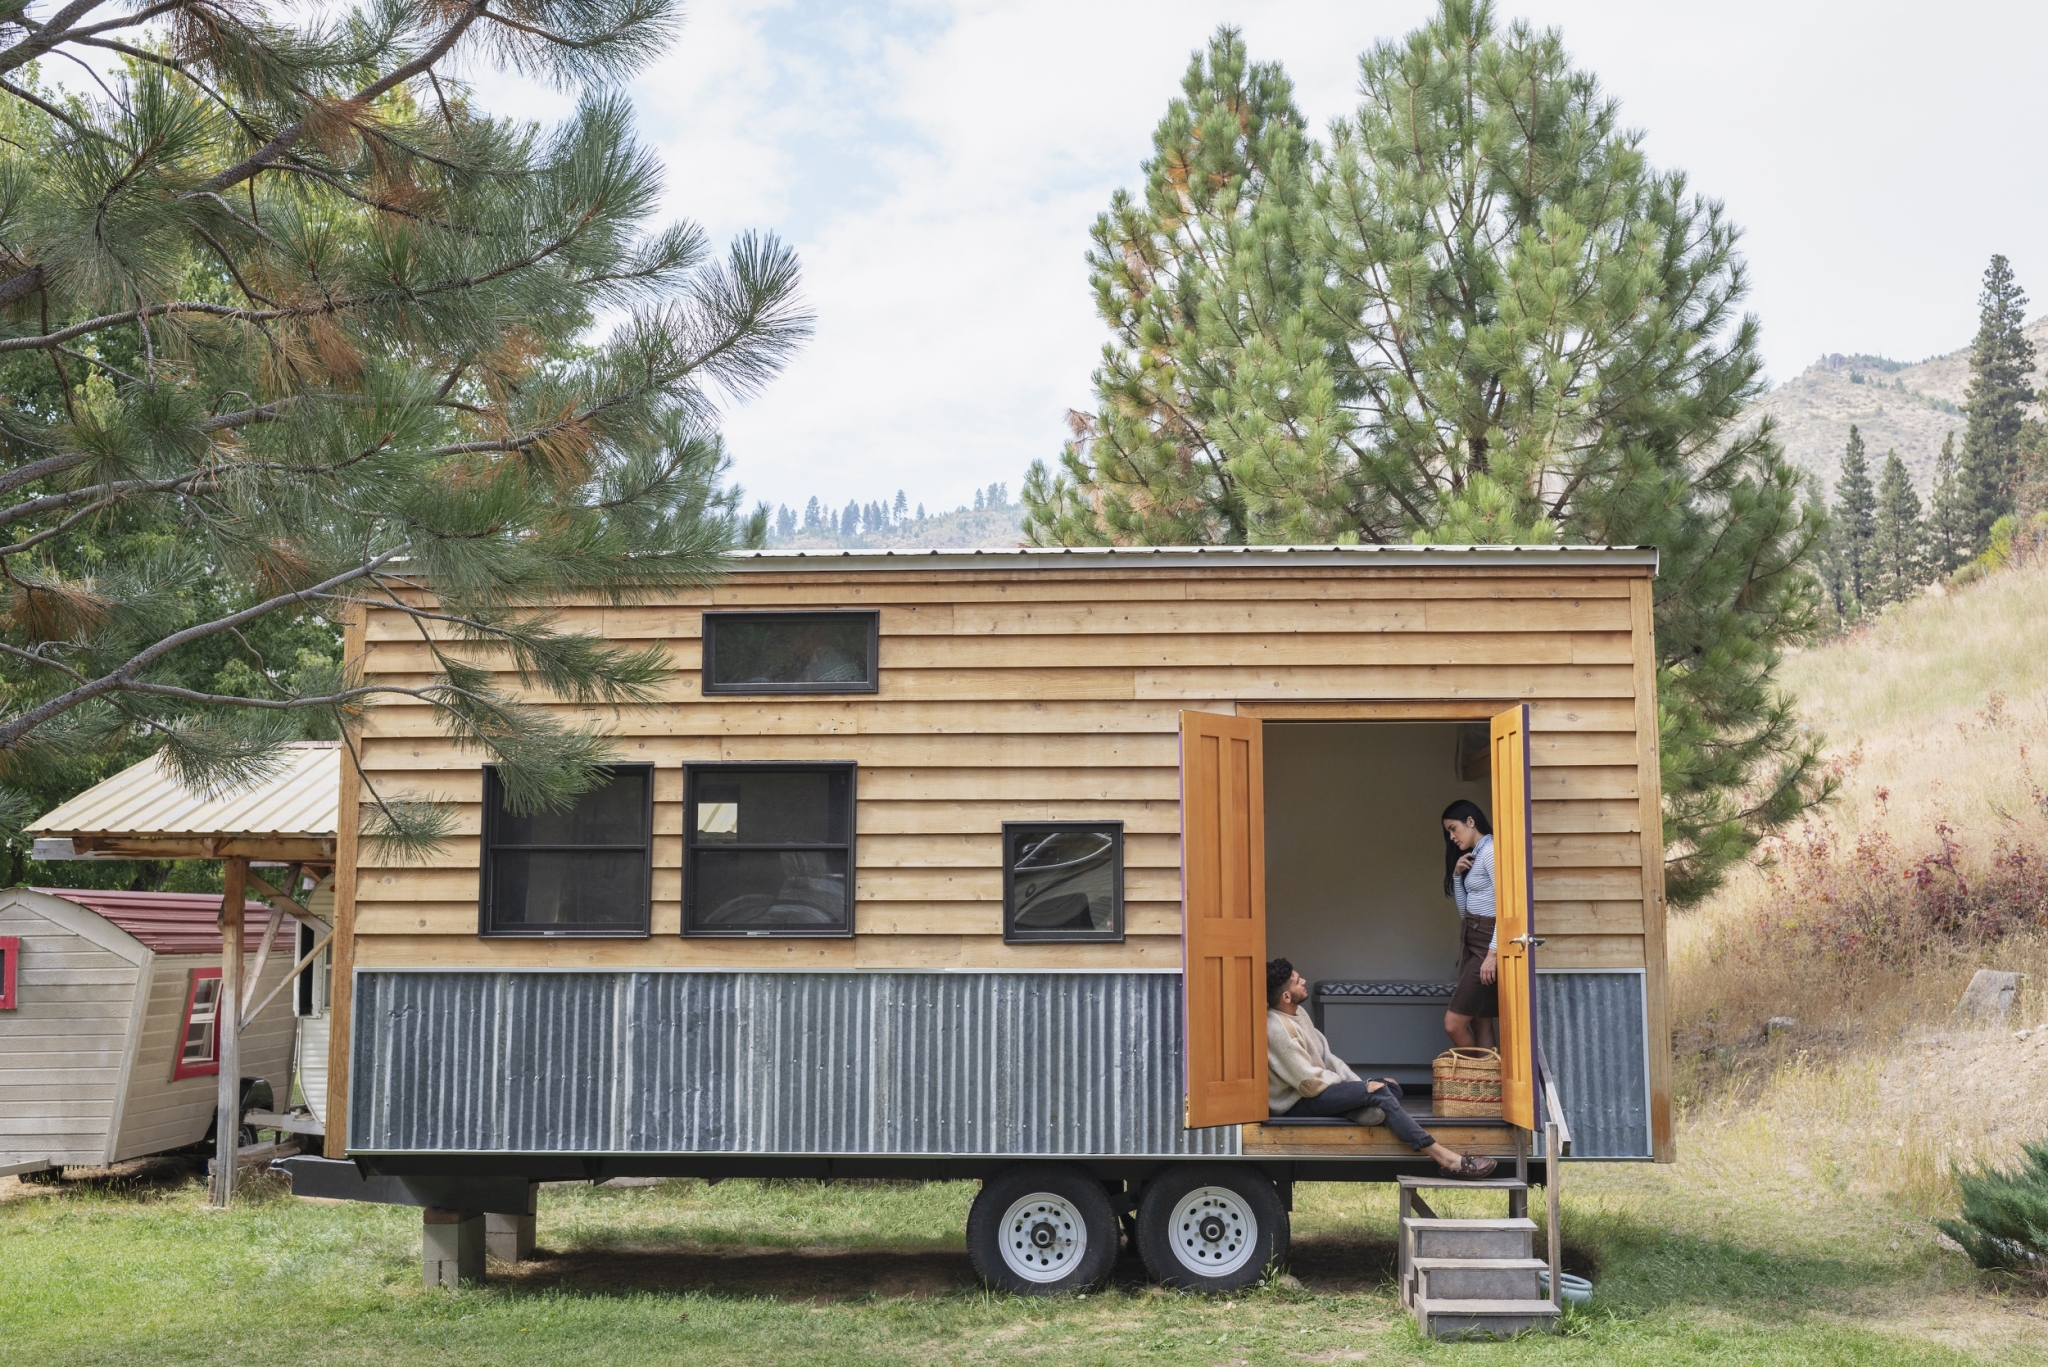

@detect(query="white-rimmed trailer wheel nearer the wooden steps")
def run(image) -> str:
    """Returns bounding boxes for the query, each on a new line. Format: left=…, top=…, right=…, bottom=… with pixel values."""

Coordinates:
left=1139, top=1164, right=1288, bottom=1291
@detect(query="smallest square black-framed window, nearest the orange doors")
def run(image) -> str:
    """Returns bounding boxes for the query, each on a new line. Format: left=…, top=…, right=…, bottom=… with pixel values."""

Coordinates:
left=1004, top=822, right=1124, bottom=945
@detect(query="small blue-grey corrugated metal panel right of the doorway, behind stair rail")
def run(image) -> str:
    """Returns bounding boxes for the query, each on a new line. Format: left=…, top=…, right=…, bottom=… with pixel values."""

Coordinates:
left=1536, top=974, right=1651, bottom=1158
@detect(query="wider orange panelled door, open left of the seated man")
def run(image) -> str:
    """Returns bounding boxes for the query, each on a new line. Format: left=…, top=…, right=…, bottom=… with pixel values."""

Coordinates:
left=1180, top=711, right=1266, bottom=1129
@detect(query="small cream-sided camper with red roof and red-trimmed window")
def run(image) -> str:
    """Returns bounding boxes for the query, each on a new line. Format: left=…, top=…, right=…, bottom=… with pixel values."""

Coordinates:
left=0, top=887, right=295, bottom=1172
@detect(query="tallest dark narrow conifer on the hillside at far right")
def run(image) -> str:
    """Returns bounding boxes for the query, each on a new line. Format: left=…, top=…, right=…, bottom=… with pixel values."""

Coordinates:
left=1962, top=256, right=2034, bottom=553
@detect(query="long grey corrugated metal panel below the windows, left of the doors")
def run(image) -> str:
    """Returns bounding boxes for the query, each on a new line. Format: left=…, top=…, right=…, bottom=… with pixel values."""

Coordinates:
left=348, top=971, right=1237, bottom=1154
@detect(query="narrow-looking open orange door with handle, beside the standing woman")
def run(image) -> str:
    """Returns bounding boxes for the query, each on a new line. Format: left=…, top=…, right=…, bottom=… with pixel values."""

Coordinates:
left=1493, top=703, right=1536, bottom=1129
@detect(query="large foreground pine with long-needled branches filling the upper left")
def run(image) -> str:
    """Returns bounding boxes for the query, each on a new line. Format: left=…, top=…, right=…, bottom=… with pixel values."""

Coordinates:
left=0, top=0, right=809, bottom=853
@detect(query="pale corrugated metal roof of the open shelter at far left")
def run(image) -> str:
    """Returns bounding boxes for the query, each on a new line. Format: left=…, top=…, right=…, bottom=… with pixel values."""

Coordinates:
left=29, top=742, right=342, bottom=838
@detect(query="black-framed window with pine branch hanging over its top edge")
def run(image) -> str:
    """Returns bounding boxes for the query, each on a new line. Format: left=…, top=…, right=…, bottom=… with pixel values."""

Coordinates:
left=477, top=764, right=653, bottom=935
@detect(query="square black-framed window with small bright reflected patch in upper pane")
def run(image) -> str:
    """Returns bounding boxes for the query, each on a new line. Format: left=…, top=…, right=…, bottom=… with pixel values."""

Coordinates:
left=682, top=764, right=854, bottom=935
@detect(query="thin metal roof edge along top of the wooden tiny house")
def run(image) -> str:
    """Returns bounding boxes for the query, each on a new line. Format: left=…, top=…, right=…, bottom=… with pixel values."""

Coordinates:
left=727, top=545, right=1657, bottom=574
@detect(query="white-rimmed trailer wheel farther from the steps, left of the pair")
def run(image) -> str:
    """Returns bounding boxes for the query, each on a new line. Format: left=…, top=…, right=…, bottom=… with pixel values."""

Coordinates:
left=967, top=1164, right=1116, bottom=1295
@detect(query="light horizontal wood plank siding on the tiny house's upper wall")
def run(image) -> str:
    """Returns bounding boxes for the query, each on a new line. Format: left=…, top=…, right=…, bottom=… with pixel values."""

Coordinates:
left=356, top=566, right=1647, bottom=969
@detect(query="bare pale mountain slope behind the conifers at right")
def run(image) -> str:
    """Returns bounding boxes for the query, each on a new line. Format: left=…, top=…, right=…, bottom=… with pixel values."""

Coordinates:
left=1743, top=318, right=2048, bottom=496
